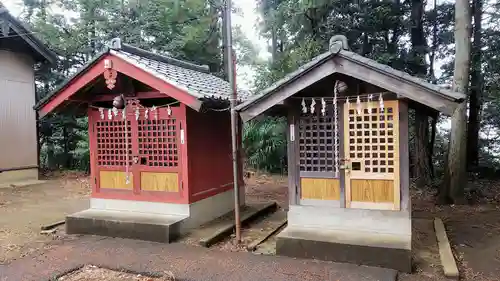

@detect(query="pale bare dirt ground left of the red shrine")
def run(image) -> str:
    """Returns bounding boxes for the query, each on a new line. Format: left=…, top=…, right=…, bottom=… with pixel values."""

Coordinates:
left=0, top=175, right=89, bottom=264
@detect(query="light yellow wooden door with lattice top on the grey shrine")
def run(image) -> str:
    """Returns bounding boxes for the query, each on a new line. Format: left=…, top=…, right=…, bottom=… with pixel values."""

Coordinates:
left=344, top=100, right=400, bottom=210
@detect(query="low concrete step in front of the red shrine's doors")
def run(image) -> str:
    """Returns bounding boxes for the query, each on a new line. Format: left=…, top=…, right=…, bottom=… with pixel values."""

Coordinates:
left=66, top=209, right=187, bottom=243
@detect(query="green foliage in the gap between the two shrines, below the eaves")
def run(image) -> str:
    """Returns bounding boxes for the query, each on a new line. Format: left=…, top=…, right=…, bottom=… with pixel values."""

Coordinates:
left=243, top=117, right=286, bottom=172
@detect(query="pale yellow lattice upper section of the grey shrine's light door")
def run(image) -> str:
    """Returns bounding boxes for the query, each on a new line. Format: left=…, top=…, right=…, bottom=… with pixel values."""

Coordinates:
left=348, top=106, right=397, bottom=173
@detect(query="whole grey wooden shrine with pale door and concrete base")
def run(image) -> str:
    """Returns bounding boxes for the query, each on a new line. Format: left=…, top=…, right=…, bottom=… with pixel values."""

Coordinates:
left=237, top=36, right=465, bottom=272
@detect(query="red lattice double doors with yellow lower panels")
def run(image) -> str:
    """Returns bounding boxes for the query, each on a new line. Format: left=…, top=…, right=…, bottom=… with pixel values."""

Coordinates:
left=89, top=103, right=184, bottom=196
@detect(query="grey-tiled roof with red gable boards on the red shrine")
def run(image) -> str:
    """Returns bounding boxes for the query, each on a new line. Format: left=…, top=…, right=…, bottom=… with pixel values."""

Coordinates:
left=34, top=39, right=247, bottom=116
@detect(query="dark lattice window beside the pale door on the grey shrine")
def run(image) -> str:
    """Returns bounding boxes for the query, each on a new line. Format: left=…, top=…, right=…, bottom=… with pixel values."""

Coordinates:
left=299, top=110, right=339, bottom=172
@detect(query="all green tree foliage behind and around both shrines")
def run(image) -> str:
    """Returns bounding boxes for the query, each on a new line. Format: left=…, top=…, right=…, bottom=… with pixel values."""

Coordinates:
left=16, top=0, right=500, bottom=176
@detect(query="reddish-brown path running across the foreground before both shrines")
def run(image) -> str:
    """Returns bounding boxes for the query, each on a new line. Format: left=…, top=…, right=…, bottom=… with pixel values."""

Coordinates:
left=0, top=236, right=395, bottom=281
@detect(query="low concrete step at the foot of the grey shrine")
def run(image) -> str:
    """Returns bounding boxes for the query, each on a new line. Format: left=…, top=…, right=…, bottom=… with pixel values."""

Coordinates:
left=276, top=227, right=411, bottom=272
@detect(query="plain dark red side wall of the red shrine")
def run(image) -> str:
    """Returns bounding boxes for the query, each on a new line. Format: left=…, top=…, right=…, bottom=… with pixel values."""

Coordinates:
left=186, top=108, right=243, bottom=203
